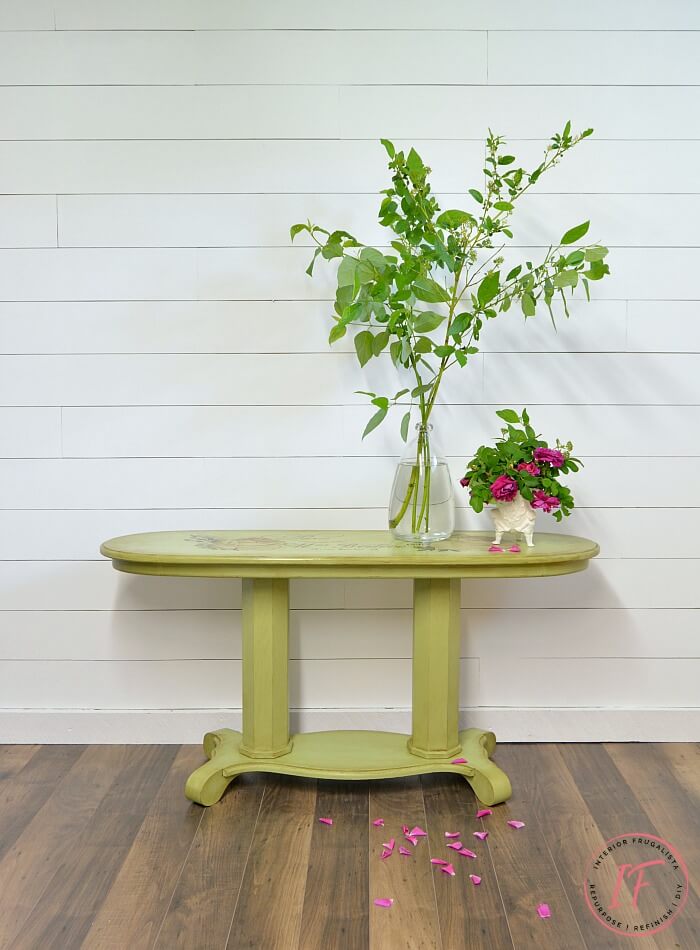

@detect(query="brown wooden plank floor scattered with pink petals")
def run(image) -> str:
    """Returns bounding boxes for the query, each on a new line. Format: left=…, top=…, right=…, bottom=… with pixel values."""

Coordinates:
left=0, top=743, right=700, bottom=950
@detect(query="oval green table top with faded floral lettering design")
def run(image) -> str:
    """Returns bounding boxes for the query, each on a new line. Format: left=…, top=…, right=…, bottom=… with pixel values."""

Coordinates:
left=100, top=530, right=600, bottom=578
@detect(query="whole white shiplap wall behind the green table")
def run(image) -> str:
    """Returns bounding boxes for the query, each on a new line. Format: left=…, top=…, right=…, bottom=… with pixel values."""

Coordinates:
left=0, top=0, right=700, bottom=741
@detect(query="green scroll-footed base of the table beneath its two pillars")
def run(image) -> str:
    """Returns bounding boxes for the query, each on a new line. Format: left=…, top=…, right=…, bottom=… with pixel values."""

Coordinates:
left=185, top=729, right=511, bottom=805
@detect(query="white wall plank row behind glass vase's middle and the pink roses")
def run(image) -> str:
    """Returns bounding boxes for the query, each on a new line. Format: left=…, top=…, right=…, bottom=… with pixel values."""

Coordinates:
left=0, top=456, right=697, bottom=517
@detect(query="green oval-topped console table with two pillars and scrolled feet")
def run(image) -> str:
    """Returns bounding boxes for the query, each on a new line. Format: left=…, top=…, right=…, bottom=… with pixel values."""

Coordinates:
left=100, top=531, right=599, bottom=805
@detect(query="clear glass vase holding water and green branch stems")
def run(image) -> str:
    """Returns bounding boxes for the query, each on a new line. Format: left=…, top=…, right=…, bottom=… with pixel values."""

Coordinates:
left=389, top=424, right=455, bottom=544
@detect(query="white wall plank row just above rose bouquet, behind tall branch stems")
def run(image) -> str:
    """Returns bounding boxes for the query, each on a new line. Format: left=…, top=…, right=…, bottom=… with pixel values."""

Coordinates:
left=0, top=353, right=700, bottom=411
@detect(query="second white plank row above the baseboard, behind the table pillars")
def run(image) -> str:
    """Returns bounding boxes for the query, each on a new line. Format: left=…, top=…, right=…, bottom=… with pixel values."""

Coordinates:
left=0, top=608, right=697, bottom=665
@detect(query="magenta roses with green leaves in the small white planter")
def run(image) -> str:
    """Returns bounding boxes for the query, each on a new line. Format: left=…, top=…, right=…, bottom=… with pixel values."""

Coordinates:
left=460, top=409, right=582, bottom=533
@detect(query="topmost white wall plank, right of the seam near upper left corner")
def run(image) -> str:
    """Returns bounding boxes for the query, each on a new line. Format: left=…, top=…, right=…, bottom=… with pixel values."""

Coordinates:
left=54, top=0, right=700, bottom=30
